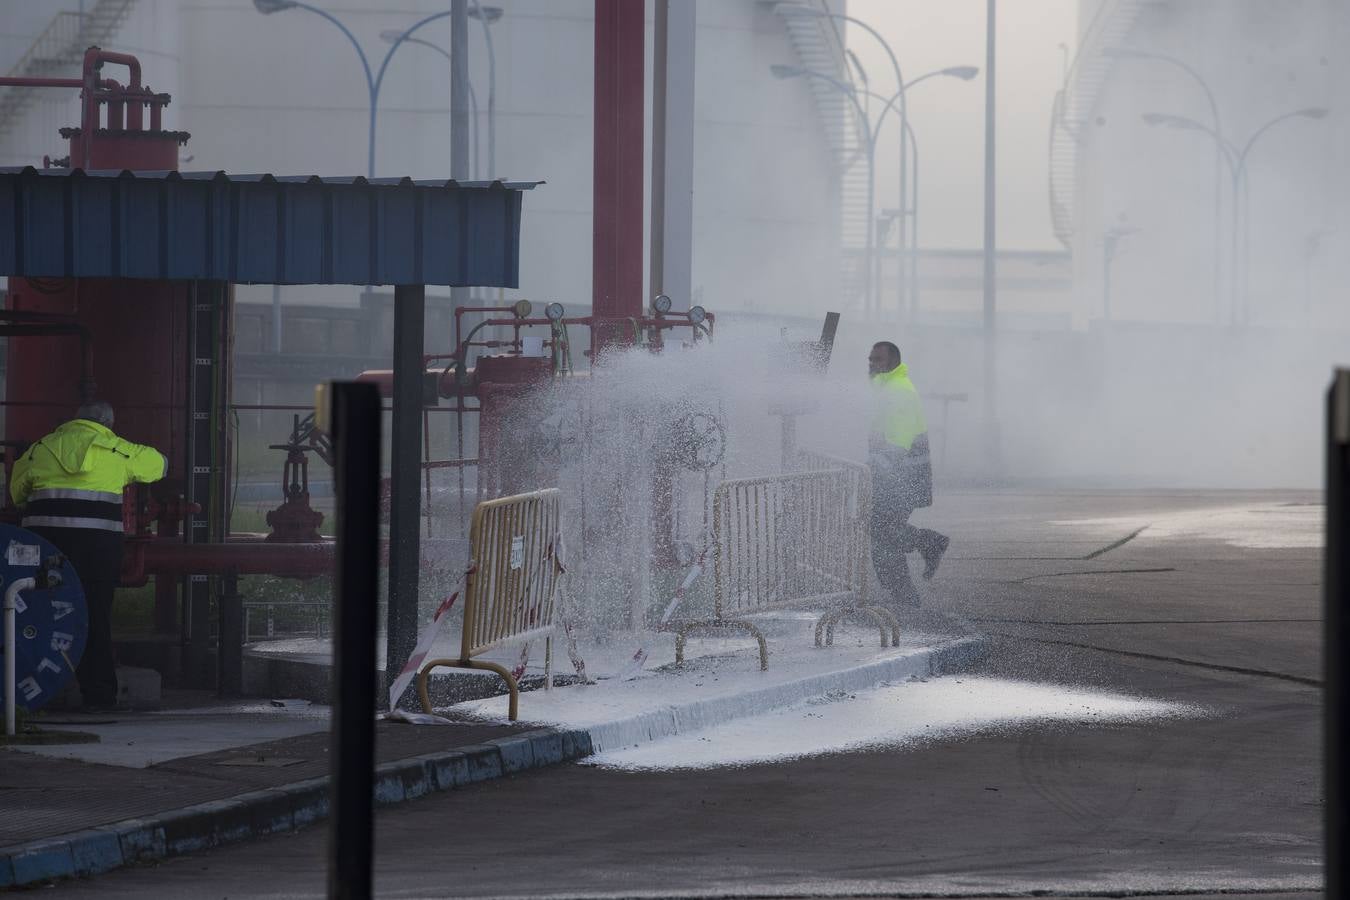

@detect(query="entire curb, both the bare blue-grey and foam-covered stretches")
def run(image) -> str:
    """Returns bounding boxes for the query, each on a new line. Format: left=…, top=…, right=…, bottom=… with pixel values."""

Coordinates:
left=0, top=637, right=987, bottom=891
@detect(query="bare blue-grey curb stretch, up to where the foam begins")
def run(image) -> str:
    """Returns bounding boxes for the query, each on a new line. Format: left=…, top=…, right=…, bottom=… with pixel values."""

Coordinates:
left=0, top=729, right=591, bottom=889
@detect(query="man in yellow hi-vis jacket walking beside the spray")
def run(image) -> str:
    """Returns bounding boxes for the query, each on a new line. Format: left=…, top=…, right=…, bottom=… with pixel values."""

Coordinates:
left=867, top=341, right=949, bottom=606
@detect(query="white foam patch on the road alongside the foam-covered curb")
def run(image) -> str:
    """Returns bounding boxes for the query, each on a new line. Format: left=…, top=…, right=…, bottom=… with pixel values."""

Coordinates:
left=587, top=676, right=1204, bottom=770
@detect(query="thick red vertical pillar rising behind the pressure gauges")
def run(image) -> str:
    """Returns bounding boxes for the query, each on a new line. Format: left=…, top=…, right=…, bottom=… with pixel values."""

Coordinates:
left=591, top=0, right=647, bottom=354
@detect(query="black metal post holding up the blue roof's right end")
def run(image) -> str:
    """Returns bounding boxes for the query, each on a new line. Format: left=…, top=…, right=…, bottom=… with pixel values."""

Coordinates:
left=385, top=285, right=427, bottom=701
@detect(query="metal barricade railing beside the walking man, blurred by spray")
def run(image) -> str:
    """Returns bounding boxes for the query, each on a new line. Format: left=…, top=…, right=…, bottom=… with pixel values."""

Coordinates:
left=675, top=453, right=899, bottom=669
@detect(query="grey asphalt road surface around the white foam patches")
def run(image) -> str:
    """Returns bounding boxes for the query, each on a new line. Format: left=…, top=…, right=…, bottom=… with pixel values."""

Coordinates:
left=49, top=494, right=1322, bottom=900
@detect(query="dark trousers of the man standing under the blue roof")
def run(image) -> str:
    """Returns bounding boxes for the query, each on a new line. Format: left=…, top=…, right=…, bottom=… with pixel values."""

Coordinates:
left=28, top=528, right=123, bottom=706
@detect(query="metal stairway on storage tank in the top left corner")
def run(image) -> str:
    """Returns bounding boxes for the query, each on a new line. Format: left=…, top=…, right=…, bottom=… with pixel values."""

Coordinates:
left=0, top=0, right=136, bottom=159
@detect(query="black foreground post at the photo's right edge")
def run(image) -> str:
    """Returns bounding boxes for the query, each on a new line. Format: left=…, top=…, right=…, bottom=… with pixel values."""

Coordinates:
left=1322, top=368, right=1350, bottom=897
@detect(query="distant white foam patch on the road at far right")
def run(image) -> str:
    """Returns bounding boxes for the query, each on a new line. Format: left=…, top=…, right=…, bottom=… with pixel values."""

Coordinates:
left=1050, top=503, right=1326, bottom=549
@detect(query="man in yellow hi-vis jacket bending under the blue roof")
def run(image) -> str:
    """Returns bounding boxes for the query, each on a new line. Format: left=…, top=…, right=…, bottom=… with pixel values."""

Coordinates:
left=9, top=402, right=169, bottom=711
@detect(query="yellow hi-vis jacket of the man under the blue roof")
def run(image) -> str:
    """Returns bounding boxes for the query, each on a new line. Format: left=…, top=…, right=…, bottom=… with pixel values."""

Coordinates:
left=9, top=418, right=169, bottom=532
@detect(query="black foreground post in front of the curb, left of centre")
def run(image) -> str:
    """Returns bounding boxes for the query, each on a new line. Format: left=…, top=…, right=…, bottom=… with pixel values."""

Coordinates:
left=319, top=382, right=379, bottom=900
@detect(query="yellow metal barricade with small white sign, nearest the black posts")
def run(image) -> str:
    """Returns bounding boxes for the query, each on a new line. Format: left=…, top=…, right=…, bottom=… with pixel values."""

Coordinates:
left=417, top=488, right=562, bottom=721
